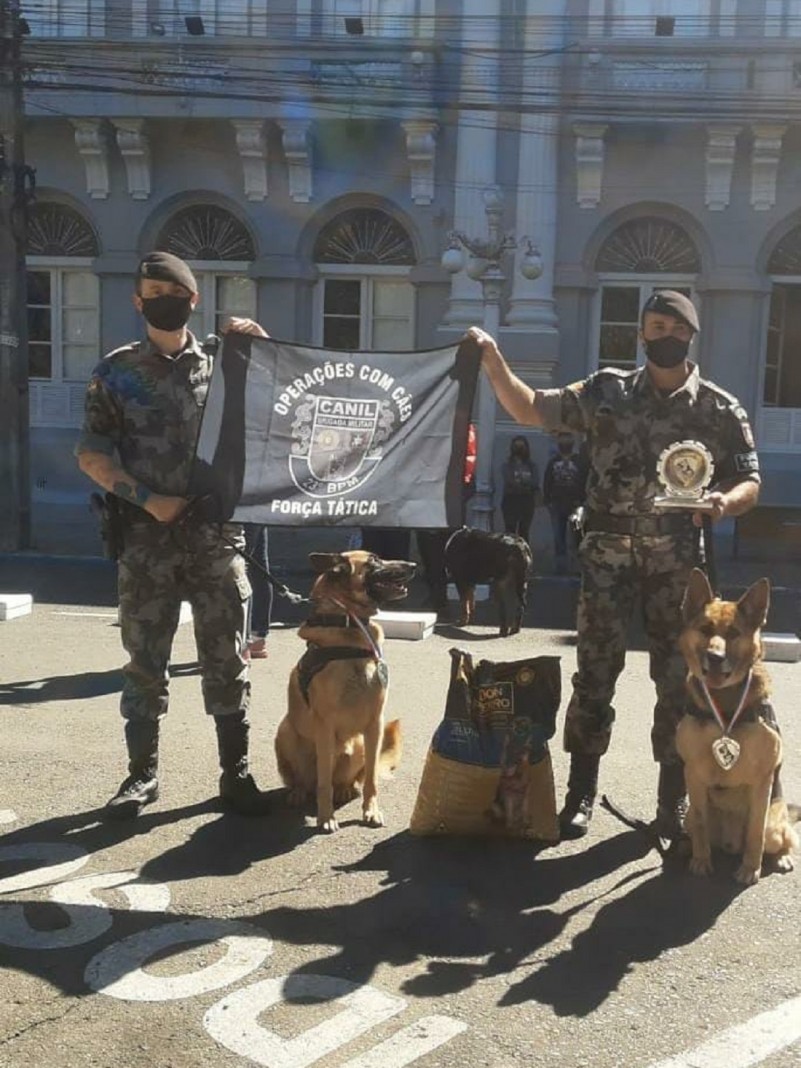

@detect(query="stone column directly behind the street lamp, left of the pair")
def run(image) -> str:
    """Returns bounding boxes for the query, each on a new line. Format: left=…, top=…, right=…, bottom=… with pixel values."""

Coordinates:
left=445, top=0, right=501, bottom=328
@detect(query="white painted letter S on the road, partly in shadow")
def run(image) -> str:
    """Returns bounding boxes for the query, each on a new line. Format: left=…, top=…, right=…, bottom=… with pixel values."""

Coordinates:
left=0, top=871, right=170, bottom=949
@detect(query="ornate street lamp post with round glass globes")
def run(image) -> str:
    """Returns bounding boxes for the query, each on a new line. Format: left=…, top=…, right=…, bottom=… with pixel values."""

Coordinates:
left=442, top=186, right=543, bottom=531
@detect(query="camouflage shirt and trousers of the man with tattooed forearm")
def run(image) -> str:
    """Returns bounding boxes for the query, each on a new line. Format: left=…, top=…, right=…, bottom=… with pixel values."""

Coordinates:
left=76, top=334, right=250, bottom=720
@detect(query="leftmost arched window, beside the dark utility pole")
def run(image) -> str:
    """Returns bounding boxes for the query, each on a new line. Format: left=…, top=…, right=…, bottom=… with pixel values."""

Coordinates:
left=26, top=202, right=100, bottom=426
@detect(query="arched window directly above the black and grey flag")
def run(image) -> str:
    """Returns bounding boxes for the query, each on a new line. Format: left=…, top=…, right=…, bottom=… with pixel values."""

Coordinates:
left=314, top=208, right=415, bottom=351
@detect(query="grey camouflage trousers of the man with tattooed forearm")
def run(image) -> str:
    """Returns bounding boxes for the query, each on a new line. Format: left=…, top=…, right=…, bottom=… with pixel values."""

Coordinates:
left=117, top=521, right=250, bottom=719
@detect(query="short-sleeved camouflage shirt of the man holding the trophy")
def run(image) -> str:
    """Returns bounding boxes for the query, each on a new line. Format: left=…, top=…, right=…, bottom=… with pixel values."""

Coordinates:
left=538, top=364, right=759, bottom=516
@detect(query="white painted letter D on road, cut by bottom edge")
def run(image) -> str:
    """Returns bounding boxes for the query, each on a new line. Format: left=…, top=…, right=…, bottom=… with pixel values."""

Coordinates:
left=203, top=975, right=406, bottom=1068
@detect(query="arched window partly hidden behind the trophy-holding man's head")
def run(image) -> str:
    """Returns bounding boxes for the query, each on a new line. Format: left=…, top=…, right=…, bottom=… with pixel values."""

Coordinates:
left=593, top=216, right=701, bottom=370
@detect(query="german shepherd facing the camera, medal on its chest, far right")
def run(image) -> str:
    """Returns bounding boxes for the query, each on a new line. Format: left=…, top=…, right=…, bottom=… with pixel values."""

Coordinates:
left=676, top=568, right=799, bottom=885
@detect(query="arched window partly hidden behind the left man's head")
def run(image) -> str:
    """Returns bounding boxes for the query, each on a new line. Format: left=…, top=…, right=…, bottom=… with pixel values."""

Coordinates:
left=156, top=204, right=257, bottom=337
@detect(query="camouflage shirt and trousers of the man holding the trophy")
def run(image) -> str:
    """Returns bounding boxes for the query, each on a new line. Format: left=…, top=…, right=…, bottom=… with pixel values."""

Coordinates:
left=544, top=364, right=759, bottom=764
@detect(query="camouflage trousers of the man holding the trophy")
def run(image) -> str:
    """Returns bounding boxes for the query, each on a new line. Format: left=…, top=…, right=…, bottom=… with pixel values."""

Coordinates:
left=564, top=531, right=696, bottom=764
